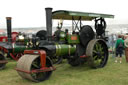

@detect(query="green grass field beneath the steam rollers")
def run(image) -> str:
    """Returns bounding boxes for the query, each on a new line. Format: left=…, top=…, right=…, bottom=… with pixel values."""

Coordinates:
left=0, top=56, right=128, bottom=85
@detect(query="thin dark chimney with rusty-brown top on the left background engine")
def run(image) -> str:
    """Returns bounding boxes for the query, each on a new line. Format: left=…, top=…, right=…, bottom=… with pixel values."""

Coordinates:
left=6, top=17, right=12, bottom=43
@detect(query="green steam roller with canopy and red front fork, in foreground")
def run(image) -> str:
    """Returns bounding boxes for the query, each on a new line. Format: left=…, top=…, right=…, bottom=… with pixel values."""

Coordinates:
left=16, top=8, right=114, bottom=82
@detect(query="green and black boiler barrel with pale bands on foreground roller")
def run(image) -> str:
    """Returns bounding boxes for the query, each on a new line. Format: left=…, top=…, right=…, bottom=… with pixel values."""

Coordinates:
left=39, top=43, right=76, bottom=56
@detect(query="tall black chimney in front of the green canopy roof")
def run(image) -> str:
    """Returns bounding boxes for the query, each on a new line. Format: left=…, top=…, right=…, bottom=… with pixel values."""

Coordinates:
left=45, top=8, right=52, bottom=41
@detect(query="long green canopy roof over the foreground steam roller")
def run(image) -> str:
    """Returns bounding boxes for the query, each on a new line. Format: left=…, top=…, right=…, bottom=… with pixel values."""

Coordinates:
left=52, top=10, right=114, bottom=21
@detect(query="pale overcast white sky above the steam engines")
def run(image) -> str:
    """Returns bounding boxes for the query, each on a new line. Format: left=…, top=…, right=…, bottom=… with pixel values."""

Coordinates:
left=0, top=0, right=128, bottom=28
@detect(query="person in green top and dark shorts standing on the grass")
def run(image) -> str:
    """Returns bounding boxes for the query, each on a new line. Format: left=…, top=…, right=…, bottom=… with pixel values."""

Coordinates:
left=115, top=35, right=124, bottom=63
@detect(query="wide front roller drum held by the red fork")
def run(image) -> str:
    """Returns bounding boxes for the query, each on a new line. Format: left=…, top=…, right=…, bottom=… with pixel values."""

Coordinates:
left=17, top=54, right=52, bottom=82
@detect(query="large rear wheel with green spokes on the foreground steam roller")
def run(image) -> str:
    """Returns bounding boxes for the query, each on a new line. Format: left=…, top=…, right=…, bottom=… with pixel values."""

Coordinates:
left=86, top=39, right=108, bottom=68
